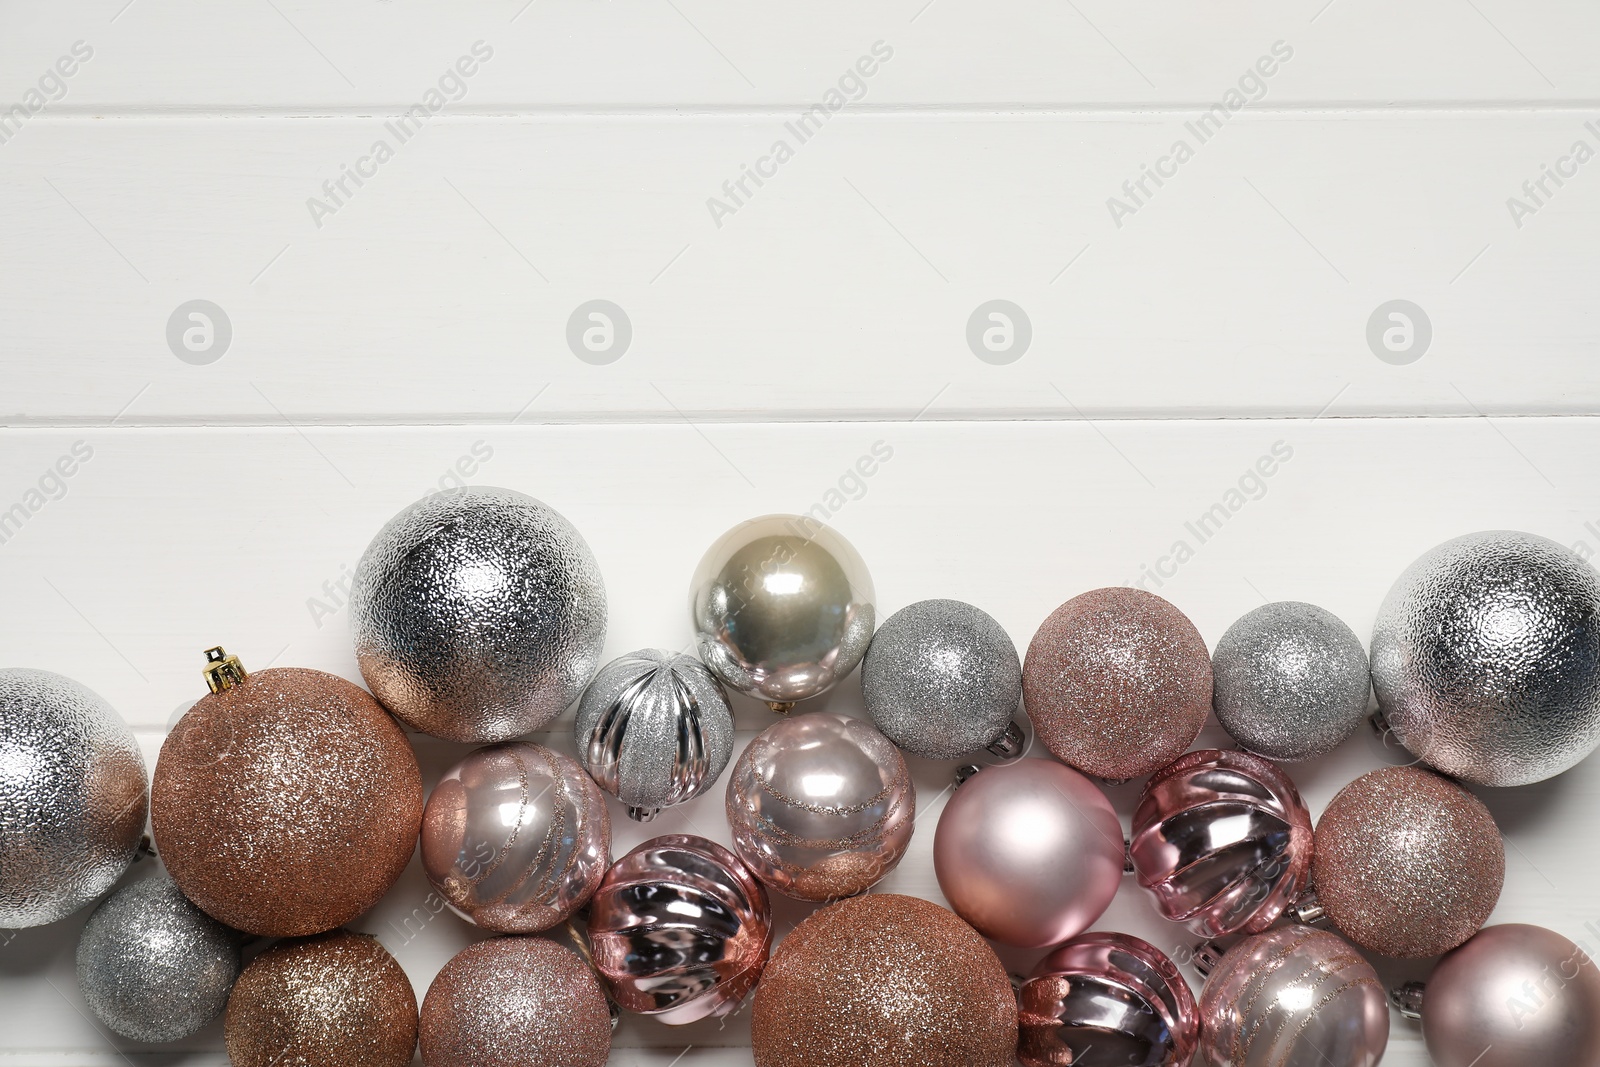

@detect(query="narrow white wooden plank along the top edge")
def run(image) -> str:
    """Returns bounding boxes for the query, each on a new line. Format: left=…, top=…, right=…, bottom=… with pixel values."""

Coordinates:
left=0, top=0, right=1600, bottom=114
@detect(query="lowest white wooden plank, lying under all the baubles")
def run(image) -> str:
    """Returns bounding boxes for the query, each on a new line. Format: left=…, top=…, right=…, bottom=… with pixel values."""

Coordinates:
left=0, top=418, right=1600, bottom=1067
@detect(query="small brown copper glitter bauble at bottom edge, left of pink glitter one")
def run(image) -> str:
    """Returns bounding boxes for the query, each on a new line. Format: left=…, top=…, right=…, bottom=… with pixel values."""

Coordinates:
left=222, top=929, right=416, bottom=1067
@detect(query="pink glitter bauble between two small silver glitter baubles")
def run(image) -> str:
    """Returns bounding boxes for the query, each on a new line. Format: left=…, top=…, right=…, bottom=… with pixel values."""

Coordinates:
left=1022, top=587, right=1211, bottom=779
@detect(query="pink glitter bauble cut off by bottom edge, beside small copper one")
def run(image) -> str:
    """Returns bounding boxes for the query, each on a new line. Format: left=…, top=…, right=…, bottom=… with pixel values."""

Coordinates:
left=421, top=937, right=611, bottom=1067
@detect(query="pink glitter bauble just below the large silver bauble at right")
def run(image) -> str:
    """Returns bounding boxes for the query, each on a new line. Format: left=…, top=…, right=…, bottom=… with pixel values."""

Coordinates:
left=1312, top=766, right=1506, bottom=960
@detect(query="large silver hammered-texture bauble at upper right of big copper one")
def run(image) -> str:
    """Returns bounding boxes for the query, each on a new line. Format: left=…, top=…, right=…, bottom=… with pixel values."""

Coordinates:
left=350, top=486, right=606, bottom=744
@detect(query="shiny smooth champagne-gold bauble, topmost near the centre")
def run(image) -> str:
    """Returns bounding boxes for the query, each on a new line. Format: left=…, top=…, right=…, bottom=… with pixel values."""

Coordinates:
left=690, top=515, right=877, bottom=710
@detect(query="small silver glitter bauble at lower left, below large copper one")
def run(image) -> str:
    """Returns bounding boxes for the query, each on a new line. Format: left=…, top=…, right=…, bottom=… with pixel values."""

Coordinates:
left=78, top=872, right=242, bottom=1041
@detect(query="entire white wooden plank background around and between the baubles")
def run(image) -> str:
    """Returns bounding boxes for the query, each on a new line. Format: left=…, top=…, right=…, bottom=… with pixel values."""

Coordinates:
left=0, top=0, right=1600, bottom=1067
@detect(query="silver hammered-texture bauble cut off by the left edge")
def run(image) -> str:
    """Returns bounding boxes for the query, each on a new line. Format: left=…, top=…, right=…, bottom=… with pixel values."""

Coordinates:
left=0, top=667, right=149, bottom=929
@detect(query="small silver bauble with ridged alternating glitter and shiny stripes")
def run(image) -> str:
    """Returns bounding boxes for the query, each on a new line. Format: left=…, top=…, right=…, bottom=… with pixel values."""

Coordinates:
left=574, top=648, right=733, bottom=819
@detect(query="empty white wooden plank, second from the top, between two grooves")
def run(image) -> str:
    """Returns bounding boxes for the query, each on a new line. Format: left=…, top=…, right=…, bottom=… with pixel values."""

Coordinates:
left=0, top=109, right=1600, bottom=424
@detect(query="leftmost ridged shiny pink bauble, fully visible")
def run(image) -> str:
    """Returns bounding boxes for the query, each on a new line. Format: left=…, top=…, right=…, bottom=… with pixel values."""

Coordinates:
left=589, top=835, right=773, bottom=1025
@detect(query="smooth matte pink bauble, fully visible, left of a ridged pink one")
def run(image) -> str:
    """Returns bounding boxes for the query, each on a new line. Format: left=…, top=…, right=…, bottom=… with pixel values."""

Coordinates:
left=933, top=760, right=1125, bottom=949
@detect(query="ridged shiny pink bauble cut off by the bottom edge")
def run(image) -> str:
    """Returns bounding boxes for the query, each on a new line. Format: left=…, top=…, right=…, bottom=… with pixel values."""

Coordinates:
left=1018, top=933, right=1200, bottom=1067
